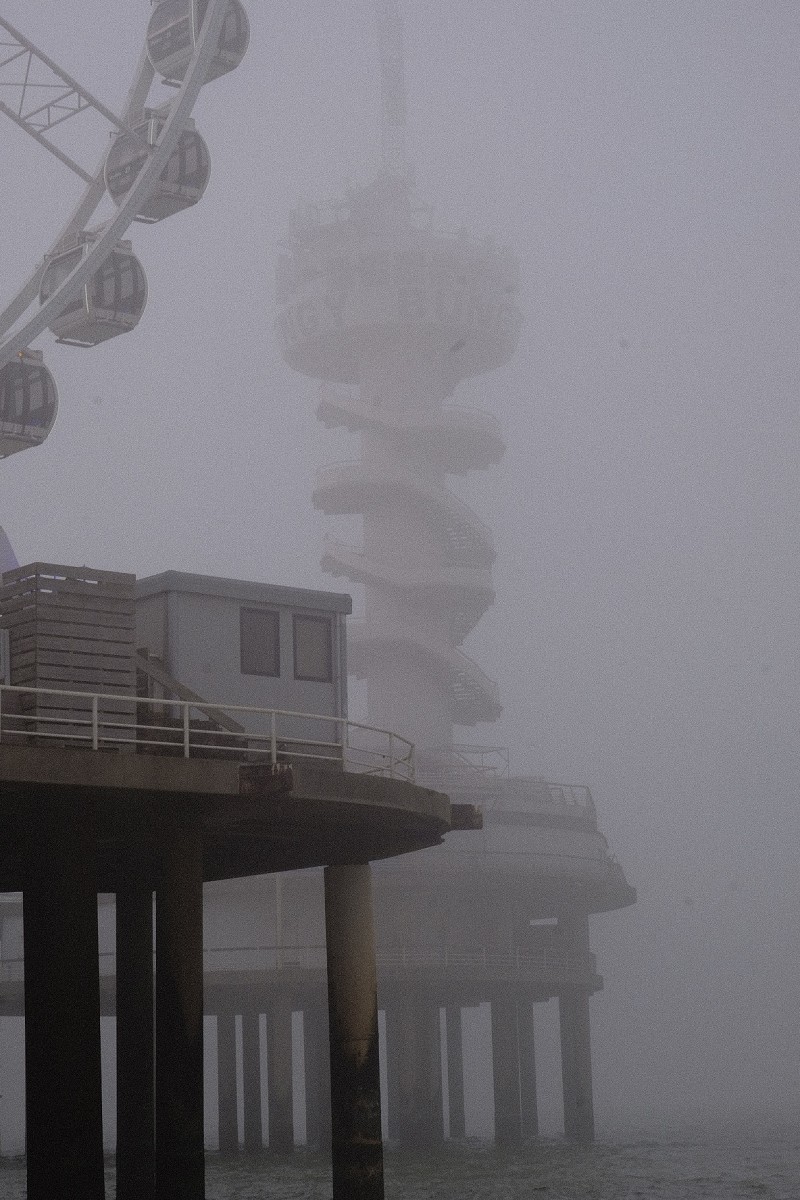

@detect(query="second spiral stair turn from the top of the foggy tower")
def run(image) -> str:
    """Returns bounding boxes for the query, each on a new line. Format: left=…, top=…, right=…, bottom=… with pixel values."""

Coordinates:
left=313, top=461, right=495, bottom=569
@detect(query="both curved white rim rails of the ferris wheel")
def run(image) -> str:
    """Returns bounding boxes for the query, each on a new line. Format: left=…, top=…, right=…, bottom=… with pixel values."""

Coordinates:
left=0, top=0, right=235, bottom=367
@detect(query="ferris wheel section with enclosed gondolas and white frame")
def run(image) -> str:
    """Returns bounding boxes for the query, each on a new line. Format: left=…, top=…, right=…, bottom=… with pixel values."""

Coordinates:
left=0, top=0, right=249, bottom=458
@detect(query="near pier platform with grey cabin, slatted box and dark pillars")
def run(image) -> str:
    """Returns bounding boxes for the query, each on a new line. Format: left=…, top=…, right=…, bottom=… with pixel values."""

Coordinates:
left=0, top=563, right=477, bottom=1200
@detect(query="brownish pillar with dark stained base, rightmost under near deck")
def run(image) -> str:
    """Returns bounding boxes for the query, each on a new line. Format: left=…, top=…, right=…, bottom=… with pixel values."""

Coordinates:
left=325, top=864, right=384, bottom=1200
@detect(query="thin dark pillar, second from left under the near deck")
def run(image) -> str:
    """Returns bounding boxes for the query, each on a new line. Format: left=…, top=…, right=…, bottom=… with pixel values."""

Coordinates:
left=116, top=871, right=156, bottom=1200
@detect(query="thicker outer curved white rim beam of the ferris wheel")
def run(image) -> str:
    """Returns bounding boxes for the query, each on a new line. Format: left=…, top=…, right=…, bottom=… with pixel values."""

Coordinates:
left=0, top=0, right=228, bottom=367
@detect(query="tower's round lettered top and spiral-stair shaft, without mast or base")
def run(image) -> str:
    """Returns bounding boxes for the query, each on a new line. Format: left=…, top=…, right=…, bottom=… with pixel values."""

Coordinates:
left=278, top=174, right=522, bottom=750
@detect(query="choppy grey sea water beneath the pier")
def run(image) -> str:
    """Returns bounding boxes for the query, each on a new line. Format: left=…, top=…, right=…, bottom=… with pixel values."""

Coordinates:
left=0, top=1129, right=800, bottom=1200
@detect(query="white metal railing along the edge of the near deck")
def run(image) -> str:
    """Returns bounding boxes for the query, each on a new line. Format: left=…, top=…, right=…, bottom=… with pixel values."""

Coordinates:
left=0, top=684, right=415, bottom=781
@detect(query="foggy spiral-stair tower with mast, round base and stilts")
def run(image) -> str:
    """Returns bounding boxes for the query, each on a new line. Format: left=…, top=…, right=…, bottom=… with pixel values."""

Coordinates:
left=277, top=0, right=636, bottom=1145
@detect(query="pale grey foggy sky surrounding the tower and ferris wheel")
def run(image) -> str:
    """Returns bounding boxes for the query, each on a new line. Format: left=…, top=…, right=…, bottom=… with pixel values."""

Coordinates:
left=0, top=0, right=800, bottom=1132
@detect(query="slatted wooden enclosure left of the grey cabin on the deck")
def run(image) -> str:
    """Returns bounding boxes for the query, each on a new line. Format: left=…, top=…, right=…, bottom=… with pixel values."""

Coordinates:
left=0, top=563, right=136, bottom=745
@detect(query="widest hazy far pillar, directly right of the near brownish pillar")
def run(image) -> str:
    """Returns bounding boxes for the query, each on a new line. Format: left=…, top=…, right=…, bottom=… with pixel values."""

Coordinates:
left=386, top=990, right=444, bottom=1148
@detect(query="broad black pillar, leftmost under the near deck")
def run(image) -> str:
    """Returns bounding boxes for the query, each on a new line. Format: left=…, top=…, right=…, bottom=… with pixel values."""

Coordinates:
left=23, top=792, right=106, bottom=1200
